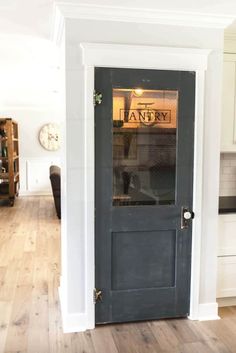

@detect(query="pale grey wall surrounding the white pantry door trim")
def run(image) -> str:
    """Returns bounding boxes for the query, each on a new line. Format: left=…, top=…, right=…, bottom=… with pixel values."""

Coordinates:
left=61, top=15, right=223, bottom=330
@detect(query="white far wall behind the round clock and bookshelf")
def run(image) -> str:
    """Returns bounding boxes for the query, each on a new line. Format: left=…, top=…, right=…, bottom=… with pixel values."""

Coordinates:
left=0, top=35, right=64, bottom=195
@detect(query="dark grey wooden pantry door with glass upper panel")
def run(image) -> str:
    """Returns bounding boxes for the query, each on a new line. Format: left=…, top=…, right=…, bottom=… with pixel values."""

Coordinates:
left=95, top=68, right=195, bottom=323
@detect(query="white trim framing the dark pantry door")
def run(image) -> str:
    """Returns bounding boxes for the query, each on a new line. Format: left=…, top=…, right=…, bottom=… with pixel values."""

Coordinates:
left=80, top=43, right=210, bottom=329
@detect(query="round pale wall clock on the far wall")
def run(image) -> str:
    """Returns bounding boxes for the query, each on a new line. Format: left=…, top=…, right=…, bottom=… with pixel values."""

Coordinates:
left=39, top=123, right=61, bottom=151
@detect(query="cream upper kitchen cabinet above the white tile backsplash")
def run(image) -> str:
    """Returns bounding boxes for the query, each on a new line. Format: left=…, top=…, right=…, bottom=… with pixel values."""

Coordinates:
left=221, top=54, right=236, bottom=152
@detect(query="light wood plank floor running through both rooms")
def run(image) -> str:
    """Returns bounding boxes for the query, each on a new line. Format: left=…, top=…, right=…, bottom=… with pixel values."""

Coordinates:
left=0, top=197, right=236, bottom=353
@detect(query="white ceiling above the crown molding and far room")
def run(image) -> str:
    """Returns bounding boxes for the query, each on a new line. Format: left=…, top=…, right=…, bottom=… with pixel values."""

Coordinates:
left=0, top=0, right=236, bottom=39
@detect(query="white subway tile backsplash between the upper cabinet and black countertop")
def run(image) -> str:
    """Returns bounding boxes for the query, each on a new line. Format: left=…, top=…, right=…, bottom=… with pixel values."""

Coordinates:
left=220, top=153, right=236, bottom=196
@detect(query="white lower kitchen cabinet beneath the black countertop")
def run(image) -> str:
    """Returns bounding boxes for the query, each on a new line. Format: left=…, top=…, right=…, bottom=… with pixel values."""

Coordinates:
left=217, top=214, right=236, bottom=298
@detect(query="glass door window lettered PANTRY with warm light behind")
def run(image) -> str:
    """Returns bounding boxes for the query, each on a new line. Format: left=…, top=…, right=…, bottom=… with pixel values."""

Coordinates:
left=113, top=88, right=178, bottom=206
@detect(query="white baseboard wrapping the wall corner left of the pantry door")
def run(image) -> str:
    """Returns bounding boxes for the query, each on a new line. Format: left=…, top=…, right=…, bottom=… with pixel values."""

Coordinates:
left=58, top=287, right=94, bottom=333
